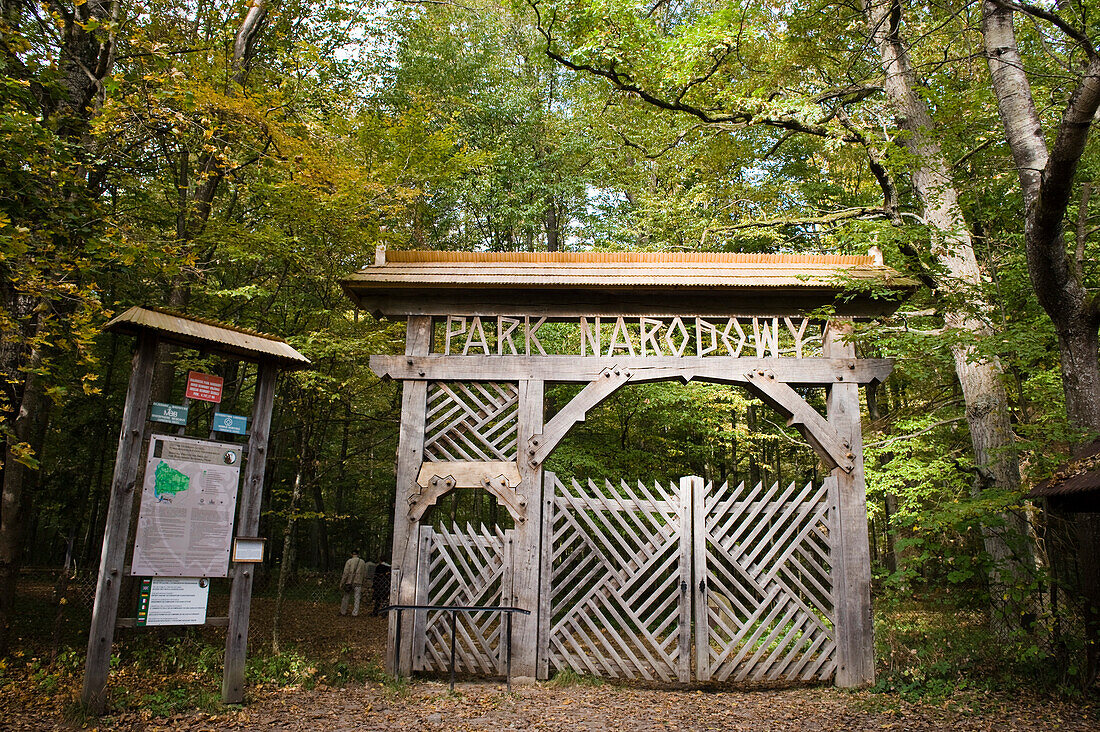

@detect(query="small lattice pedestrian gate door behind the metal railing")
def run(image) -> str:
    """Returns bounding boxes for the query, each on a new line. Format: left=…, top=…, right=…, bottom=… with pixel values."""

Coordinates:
left=413, top=524, right=514, bottom=675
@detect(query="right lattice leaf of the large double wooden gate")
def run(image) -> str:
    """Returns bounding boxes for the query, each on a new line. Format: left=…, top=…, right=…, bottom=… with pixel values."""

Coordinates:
left=694, top=479, right=836, bottom=680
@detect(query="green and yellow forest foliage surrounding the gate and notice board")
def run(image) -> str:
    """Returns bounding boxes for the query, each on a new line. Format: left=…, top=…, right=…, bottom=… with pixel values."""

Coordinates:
left=0, top=0, right=1100, bottom=713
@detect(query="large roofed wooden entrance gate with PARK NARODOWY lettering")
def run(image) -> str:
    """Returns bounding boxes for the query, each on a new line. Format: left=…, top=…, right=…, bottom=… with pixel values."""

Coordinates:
left=342, top=249, right=917, bottom=687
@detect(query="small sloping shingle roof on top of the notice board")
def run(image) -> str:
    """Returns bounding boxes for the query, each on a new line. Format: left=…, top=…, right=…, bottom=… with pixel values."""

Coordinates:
left=103, top=306, right=309, bottom=369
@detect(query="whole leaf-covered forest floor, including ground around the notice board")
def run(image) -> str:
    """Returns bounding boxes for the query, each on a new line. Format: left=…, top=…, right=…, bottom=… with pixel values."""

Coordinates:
left=0, top=585, right=1100, bottom=732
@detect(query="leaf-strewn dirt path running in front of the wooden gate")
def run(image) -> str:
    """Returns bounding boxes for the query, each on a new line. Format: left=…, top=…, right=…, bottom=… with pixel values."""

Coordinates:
left=210, top=682, right=1100, bottom=732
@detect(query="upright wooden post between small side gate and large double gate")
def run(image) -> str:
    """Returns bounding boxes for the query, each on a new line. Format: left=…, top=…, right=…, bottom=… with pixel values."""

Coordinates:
left=512, top=381, right=545, bottom=681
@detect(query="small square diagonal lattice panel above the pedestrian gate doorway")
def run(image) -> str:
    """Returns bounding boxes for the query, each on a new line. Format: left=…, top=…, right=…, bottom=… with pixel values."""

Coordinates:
left=424, top=381, right=519, bottom=462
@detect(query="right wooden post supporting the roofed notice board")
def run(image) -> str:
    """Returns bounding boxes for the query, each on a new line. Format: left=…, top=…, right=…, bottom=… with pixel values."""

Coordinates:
left=221, top=362, right=278, bottom=704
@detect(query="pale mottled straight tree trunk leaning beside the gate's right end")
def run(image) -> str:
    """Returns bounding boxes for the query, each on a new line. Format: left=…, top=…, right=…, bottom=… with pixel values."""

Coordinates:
left=864, top=0, right=1030, bottom=626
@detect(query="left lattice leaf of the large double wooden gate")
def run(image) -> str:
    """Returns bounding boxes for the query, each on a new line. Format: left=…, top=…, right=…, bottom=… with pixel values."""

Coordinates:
left=543, top=473, right=691, bottom=680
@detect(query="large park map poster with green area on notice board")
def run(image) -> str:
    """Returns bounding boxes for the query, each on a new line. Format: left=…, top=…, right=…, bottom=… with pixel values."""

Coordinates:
left=131, top=435, right=241, bottom=577
